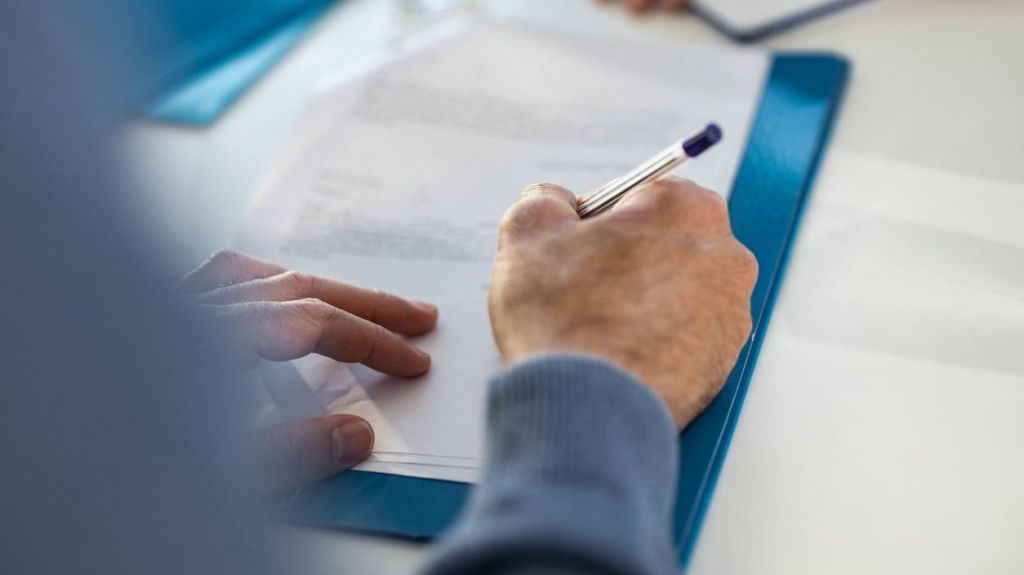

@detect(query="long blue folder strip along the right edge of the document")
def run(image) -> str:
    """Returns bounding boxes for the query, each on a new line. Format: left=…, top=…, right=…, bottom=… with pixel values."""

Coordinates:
left=675, top=54, right=849, bottom=566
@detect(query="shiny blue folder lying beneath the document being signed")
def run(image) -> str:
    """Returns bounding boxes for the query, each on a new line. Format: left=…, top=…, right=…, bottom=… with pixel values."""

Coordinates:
left=276, top=53, right=849, bottom=566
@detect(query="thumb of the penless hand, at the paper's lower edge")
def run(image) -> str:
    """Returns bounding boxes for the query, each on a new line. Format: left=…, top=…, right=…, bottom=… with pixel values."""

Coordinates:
left=249, top=415, right=374, bottom=491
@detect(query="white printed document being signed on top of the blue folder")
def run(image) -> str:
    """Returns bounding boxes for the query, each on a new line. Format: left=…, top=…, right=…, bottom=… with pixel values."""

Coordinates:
left=239, top=21, right=768, bottom=481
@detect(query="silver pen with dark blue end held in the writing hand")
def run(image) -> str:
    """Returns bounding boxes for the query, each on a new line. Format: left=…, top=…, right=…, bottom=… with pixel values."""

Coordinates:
left=577, top=124, right=722, bottom=219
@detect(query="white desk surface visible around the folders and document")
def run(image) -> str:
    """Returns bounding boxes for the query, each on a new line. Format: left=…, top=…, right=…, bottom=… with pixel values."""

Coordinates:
left=128, top=0, right=1024, bottom=575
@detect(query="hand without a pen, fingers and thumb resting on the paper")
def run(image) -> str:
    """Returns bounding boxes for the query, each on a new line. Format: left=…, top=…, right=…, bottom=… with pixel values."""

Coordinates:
left=181, top=252, right=437, bottom=490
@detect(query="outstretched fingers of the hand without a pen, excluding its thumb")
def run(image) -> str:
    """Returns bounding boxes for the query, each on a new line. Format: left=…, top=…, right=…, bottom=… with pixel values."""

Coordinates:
left=181, top=252, right=437, bottom=378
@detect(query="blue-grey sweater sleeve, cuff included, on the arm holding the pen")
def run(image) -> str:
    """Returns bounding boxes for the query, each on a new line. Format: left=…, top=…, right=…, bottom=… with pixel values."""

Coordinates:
left=425, top=355, right=678, bottom=575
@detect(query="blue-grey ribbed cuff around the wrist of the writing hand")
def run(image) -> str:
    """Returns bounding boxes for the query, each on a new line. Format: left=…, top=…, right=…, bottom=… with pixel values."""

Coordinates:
left=487, top=354, right=677, bottom=501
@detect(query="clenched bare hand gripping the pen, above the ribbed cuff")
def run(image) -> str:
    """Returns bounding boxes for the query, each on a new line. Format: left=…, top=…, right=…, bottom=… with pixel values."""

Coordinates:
left=489, top=179, right=758, bottom=429
